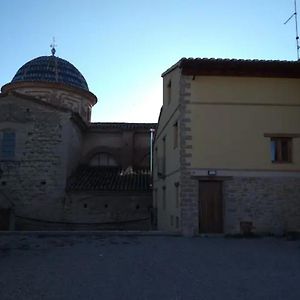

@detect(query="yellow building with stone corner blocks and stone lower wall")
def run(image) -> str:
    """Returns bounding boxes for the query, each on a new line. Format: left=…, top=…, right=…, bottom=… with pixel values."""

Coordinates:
left=153, top=59, right=300, bottom=235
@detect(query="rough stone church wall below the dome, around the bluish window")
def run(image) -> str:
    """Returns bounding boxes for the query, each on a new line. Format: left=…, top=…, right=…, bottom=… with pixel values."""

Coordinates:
left=0, top=96, right=71, bottom=226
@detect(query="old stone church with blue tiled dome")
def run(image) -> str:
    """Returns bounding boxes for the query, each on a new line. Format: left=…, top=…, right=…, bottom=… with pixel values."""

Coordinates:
left=0, top=53, right=156, bottom=230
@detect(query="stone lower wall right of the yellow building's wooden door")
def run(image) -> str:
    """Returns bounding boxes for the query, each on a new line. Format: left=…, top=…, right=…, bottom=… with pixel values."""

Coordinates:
left=223, top=177, right=300, bottom=235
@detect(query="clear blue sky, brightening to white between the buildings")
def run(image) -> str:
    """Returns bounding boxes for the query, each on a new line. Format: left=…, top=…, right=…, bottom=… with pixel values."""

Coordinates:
left=0, top=0, right=300, bottom=122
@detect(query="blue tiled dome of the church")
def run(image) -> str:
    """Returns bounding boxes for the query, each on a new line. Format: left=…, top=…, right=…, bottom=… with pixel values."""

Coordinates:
left=11, top=56, right=89, bottom=91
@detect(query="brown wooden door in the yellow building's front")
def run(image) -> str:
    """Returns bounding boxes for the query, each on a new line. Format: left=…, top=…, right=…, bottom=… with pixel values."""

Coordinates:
left=199, top=181, right=223, bottom=233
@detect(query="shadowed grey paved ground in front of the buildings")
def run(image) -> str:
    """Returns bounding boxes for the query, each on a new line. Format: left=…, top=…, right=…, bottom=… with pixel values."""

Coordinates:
left=0, top=234, right=300, bottom=300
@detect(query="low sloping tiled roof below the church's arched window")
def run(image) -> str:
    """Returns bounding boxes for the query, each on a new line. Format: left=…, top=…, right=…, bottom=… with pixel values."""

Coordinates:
left=67, top=166, right=151, bottom=192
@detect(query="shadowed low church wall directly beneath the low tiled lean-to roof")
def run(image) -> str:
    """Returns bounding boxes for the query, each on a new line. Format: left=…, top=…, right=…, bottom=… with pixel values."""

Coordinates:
left=64, top=191, right=152, bottom=230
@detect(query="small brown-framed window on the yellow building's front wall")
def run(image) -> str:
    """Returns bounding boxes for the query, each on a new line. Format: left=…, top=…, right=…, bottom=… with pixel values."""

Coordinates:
left=271, top=137, right=292, bottom=163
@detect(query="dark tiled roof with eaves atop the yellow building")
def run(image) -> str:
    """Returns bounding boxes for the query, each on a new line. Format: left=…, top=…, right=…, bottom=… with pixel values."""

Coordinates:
left=162, top=57, right=300, bottom=78
